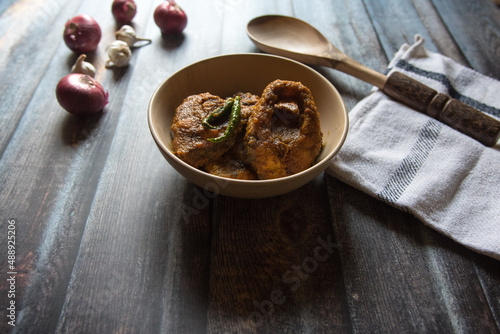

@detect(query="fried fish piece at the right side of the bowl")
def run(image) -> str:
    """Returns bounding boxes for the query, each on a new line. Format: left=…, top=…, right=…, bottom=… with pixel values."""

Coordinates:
left=244, top=80, right=322, bottom=179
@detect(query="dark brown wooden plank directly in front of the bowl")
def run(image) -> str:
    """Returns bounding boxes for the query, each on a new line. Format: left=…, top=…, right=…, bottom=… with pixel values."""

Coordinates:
left=208, top=177, right=349, bottom=333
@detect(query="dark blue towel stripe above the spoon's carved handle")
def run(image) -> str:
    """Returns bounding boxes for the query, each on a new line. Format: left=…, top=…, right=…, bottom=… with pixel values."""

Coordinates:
left=396, top=59, right=500, bottom=117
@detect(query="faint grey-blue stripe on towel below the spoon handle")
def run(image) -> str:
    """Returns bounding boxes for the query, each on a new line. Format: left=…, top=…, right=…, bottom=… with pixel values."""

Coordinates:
left=378, top=119, right=443, bottom=204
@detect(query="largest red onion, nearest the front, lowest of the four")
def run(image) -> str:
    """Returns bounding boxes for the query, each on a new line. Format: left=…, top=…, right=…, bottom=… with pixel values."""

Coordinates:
left=56, top=73, right=108, bottom=116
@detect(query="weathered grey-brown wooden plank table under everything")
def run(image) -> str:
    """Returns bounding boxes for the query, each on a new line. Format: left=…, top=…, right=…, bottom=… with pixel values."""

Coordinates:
left=0, top=0, right=500, bottom=333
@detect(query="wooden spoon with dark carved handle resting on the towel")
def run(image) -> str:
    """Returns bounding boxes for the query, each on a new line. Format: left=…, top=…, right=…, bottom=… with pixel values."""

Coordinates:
left=247, top=15, right=500, bottom=146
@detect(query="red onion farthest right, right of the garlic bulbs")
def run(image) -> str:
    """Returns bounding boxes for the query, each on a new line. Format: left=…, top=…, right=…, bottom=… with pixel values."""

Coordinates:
left=154, top=0, right=187, bottom=34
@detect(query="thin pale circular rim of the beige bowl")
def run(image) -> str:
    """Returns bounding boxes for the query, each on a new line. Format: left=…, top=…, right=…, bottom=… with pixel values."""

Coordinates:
left=147, top=52, right=349, bottom=185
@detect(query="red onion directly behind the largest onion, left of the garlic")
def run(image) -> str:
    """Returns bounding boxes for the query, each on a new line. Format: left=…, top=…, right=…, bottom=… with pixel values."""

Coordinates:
left=63, top=14, right=101, bottom=53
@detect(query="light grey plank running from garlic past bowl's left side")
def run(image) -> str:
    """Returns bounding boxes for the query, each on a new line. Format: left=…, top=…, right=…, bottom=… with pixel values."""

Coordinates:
left=53, top=4, right=225, bottom=333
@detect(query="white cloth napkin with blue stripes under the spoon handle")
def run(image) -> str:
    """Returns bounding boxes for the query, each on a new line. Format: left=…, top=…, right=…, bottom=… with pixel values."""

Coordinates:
left=327, top=36, right=500, bottom=259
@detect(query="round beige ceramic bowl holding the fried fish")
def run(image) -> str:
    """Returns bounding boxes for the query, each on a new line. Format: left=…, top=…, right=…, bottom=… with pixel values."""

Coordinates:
left=148, top=53, right=348, bottom=198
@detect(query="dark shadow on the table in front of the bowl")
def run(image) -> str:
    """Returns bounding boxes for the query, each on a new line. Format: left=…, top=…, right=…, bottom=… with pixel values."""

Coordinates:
left=157, top=177, right=347, bottom=332
